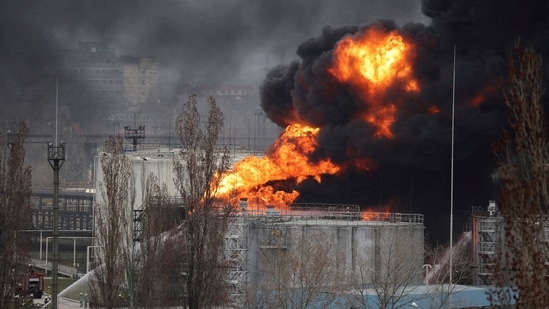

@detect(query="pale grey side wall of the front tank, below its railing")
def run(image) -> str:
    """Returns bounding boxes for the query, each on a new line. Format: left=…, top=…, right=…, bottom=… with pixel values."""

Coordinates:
left=246, top=217, right=424, bottom=288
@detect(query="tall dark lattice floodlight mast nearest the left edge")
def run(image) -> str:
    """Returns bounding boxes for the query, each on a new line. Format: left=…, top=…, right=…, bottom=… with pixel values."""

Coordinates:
left=48, top=142, right=67, bottom=309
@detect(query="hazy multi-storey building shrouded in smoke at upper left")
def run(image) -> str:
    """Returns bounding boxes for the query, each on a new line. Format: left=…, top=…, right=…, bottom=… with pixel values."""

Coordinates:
left=60, top=42, right=158, bottom=112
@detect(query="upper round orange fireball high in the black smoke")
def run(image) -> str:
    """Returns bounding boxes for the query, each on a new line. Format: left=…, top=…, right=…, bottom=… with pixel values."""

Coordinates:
left=329, top=27, right=419, bottom=138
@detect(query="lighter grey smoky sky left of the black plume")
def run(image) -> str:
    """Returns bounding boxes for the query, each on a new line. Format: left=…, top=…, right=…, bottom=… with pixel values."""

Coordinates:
left=0, top=0, right=421, bottom=124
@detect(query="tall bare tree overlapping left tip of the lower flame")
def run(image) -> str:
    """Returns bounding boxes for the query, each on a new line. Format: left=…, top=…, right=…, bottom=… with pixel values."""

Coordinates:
left=174, top=95, right=233, bottom=309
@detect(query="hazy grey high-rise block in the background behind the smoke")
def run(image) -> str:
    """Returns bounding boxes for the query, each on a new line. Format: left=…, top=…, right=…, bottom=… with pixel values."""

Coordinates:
left=59, top=42, right=159, bottom=132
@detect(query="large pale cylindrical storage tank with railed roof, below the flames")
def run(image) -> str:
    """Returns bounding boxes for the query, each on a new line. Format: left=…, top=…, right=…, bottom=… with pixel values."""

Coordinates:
left=229, top=204, right=424, bottom=286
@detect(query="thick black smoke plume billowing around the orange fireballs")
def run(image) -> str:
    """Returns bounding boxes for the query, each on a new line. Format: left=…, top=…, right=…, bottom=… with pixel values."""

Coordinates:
left=261, top=0, right=549, bottom=238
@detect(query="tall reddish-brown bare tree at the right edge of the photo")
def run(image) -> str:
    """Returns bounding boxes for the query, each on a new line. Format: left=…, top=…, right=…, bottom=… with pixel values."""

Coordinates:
left=490, top=42, right=549, bottom=308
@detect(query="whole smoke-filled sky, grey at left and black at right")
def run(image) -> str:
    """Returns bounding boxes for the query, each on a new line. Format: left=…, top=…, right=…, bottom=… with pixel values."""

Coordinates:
left=0, top=0, right=549, bottom=241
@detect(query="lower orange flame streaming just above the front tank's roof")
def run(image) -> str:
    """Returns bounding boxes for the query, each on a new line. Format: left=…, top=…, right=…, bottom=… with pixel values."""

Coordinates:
left=217, top=124, right=340, bottom=207
